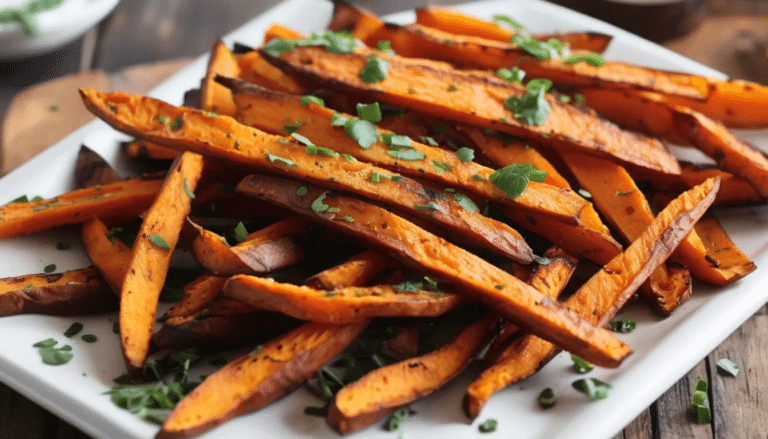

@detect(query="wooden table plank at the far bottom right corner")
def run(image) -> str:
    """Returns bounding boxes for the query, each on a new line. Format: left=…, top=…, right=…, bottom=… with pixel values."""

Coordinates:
left=707, top=306, right=768, bottom=439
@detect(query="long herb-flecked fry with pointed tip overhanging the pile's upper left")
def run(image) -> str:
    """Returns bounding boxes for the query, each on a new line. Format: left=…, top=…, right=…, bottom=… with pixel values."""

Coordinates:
left=81, top=90, right=531, bottom=261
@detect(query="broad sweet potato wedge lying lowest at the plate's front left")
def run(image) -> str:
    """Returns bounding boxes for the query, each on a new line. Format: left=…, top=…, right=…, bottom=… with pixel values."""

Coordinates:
left=156, top=323, right=367, bottom=439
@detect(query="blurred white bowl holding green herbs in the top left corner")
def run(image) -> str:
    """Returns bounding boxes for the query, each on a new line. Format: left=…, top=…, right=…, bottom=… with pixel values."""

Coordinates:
left=0, top=0, right=119, bottom=60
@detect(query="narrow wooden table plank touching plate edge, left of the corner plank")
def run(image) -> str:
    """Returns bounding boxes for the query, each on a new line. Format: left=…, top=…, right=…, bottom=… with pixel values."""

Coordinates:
left=656, top=360, right=713, bottom=439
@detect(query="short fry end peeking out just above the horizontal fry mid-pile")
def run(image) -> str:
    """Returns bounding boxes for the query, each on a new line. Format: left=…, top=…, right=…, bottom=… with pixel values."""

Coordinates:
left=304, top=250, right=392, bottom=290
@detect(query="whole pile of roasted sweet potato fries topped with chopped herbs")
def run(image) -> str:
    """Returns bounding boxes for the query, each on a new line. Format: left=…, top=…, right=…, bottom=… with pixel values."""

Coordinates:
left=0, top=3, right=768, bottom=438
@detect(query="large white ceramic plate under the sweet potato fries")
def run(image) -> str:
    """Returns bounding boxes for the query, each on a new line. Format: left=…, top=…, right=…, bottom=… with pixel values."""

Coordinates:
left=0, top=0, right=768, bottom=439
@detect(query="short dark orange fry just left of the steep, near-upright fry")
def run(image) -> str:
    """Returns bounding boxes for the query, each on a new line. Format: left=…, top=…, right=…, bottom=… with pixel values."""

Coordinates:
left=80, top=218, right=133, bottom=295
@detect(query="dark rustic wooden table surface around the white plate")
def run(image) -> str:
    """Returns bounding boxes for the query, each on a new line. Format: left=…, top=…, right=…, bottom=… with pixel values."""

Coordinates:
left=0, top=0, right=768, bottom=439
